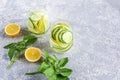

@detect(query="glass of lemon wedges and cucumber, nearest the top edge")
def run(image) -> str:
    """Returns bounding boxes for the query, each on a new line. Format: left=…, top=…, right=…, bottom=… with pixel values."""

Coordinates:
left=28, top=9, right=50, bottom=36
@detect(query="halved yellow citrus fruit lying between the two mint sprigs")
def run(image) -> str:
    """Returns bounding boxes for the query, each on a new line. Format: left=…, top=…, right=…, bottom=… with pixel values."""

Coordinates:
left=25, top=47, right=41, bottom=62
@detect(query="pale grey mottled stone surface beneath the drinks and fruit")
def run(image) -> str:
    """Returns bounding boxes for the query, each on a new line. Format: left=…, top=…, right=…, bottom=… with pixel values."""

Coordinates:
left=0, top=0, right=120, bottom=80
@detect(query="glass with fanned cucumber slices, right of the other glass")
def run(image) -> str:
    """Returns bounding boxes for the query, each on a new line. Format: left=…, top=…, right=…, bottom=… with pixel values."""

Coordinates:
left=50, top=22, right=73, bottom=53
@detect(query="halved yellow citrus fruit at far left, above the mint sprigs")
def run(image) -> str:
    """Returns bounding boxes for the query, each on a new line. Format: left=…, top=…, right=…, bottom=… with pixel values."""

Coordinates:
left=5, top=23, right=20, bottom=36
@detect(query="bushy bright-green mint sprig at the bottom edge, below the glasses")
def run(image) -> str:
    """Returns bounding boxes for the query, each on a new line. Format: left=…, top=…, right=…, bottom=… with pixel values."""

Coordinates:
left=26, top=52, right=72, bottom=80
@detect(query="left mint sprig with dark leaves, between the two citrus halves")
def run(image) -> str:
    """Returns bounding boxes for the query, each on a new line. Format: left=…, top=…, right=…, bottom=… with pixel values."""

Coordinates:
left=4, top=35, right=37, bottom=68
